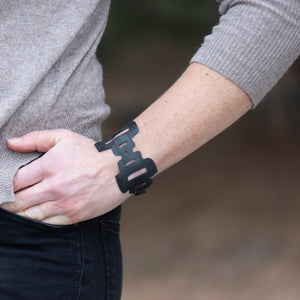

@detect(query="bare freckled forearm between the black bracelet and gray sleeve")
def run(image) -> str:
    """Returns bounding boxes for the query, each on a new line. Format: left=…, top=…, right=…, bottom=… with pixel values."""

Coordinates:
left=134, top=63, right=252, bottom=172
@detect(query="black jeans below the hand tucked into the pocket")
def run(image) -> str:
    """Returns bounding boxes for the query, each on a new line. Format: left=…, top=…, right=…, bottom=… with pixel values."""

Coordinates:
left=0, top=207, right=122, bottom=300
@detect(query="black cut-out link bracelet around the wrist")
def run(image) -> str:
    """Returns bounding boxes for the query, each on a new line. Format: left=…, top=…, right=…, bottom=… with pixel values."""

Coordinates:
left=95, top=121, right=157, bottom=195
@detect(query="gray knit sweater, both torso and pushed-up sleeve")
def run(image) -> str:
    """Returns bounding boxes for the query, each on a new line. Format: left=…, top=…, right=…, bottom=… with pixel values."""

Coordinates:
left=0, top=0, right=300, bottom=203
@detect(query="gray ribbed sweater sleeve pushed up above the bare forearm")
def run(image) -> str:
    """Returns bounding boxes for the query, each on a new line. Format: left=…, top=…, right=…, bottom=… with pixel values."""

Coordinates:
left=191, top=0, right=300, bottom=106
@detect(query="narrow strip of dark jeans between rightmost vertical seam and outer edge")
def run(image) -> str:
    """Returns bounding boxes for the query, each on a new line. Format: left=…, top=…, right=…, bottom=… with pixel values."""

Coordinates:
left=99, top=219, right=122, bottom=300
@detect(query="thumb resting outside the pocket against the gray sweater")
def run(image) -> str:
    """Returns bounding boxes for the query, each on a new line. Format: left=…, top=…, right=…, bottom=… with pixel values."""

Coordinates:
left=7, top=129, right=73, bottom=152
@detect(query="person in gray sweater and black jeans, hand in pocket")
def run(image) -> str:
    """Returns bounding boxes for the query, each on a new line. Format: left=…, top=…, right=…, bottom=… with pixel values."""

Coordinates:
left=0, top=0, right=300, bottom=300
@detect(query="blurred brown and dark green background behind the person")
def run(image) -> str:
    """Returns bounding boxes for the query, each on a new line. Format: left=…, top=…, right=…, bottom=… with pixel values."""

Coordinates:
left=98, top=0, right=300, bottom=300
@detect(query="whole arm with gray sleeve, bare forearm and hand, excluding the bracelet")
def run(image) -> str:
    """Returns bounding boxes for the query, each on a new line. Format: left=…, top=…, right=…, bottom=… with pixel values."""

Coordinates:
left=4, top=0, right=300, bottom=224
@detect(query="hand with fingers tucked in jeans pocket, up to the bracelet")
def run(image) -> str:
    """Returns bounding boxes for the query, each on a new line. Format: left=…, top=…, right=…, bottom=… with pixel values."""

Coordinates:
left=2, top=129, right=129, bottom=225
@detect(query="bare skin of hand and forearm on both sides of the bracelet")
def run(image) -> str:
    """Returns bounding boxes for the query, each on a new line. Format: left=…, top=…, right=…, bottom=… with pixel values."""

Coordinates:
left=2, top=63, right=252, bottom=225
